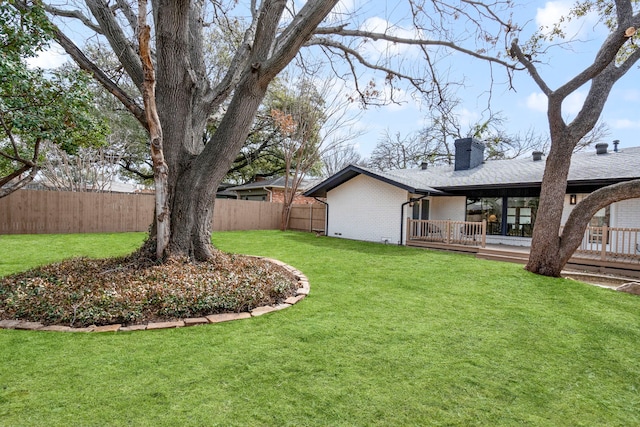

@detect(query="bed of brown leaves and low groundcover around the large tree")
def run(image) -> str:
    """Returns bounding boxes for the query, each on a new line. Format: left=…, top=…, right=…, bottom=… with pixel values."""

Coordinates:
left=0, top=253, right=298, bottom=327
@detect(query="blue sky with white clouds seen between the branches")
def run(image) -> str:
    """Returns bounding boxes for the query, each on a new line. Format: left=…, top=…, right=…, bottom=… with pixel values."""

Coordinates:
left=30, top=0, right=640, bottom=161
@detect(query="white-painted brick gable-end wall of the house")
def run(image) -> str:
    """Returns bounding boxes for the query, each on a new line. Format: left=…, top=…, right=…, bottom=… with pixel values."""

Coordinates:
left=327, top=175, right=408, bottom=244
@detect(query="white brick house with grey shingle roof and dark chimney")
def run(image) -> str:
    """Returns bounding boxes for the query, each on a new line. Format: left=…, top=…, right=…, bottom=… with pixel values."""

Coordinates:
left=305, top=138, right=640, bottom=250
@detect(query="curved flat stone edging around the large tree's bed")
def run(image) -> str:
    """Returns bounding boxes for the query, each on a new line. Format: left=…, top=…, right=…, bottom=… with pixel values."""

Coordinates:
left=0, top=255, right=311, bottom=332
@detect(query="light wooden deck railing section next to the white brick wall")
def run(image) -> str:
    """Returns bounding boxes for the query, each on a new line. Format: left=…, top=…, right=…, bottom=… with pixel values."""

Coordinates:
left=407, top=219, right=487, bottom=248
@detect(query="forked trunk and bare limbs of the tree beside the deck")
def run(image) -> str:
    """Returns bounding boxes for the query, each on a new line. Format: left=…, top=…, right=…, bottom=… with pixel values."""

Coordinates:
left=511, top=10, right=640, bottom=277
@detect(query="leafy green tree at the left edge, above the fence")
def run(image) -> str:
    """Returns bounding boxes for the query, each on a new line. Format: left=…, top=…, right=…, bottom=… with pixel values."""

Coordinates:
left=0, top=2, right=106, bottom=197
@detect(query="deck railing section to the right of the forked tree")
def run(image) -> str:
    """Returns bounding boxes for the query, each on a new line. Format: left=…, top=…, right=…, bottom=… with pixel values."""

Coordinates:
left=576, top=225, right=640, bottom=261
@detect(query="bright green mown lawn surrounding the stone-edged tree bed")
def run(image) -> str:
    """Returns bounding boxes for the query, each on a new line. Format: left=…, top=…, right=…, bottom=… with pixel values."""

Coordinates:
left=0, top=231, right=640, bottom=426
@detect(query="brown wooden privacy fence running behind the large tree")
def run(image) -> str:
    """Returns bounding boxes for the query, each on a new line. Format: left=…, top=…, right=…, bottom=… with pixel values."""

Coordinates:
left=0, top=190, right=325, bottom=234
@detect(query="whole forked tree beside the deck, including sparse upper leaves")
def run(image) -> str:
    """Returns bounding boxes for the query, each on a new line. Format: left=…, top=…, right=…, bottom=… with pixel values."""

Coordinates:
left=511, top=0, right=640, bottom=276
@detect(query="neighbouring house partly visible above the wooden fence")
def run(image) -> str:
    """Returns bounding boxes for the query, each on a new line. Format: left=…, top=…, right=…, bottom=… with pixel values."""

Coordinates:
left=225, top=176, right=317, bottom=204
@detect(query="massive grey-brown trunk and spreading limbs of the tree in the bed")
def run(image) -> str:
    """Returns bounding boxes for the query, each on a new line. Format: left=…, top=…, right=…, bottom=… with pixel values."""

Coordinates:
left=51, top=0, right=338, bottom=260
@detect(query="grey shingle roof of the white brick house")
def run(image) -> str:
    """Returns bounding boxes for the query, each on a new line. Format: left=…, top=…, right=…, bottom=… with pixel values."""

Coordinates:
left=305, top=147, right=640, bottom=197
